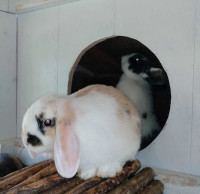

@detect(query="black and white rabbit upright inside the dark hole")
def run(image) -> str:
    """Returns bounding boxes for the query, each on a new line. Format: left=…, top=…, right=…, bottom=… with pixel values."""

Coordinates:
left=116, top=53, right=164, bottom=147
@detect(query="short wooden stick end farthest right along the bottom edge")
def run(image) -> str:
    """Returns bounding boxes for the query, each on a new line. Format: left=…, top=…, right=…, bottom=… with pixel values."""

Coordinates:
left=137, top=180, right=164, bottom=194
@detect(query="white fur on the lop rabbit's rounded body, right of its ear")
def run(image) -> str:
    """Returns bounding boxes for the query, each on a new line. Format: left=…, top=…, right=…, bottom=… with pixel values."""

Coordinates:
left=70, top=92, right=139, bottom=178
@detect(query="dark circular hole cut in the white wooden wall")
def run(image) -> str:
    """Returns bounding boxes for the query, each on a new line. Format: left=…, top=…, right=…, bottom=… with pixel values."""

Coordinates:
left=68, top=36, right=171, bottom=150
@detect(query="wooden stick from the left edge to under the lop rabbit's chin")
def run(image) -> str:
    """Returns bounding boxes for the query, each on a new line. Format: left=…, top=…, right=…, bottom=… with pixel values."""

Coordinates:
left=0, top=160, right=52, bottom=191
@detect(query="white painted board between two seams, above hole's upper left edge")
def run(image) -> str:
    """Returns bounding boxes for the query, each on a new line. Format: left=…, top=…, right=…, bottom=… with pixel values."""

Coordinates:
left=58, top=0, right=115, bottom=94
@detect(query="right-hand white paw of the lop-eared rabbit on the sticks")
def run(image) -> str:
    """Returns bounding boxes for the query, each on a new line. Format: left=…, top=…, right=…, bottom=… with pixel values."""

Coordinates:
left=97, top=162, right=122, bottom=178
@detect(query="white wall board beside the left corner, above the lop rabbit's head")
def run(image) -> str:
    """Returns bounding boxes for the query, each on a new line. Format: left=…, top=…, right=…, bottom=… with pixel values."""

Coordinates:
left=17, top=7, right=58, bottom=136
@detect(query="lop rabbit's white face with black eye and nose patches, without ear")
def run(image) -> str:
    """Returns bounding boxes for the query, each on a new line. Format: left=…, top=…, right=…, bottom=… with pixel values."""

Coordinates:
left=21, top=97, right=56, bottom=158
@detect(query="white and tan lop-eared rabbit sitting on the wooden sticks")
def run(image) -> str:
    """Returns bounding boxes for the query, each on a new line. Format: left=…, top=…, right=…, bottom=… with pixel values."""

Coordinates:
left=22, top=85, right=141, bottom=179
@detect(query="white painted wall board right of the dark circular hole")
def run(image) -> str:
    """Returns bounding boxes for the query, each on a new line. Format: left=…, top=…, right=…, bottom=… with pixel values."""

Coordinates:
left=116, top=0, right=195, bottom=173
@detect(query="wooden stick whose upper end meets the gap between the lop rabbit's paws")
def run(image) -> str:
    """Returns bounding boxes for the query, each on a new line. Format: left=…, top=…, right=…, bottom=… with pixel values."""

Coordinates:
left=67, top=177, right=105, bottom=194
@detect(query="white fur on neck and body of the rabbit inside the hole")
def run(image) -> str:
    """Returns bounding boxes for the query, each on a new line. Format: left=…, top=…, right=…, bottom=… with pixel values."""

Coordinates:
left=116, top=54, right=160, bottom=138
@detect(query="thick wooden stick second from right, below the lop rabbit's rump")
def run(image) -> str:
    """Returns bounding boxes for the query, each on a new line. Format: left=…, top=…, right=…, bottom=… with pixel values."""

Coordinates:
left=110, top=168, right=155, bottom=194
